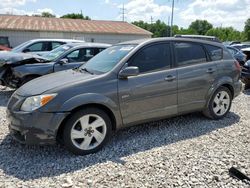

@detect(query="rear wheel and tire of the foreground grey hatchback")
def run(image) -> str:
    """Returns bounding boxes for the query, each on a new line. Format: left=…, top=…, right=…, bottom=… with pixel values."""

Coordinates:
left=203, top=86, right=232, bottom=119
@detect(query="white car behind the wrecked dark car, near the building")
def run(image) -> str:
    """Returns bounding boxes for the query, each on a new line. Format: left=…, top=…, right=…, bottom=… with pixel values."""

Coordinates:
left=12, top=39, right=84, bottom=55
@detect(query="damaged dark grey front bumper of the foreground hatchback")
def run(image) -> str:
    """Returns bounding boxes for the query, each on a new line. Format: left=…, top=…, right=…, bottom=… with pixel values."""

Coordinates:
left=7, top=110, right=67, bottom=145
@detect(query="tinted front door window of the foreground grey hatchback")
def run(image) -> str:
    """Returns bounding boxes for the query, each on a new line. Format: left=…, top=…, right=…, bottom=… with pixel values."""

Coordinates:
left=129, top=43, right=171, bottom=73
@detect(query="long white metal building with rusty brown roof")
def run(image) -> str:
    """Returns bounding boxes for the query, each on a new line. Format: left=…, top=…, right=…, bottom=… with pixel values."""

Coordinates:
left=0, top=15, right=152, bottom=47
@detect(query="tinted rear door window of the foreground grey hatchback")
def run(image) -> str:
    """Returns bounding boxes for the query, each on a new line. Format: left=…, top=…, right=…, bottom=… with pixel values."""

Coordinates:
left=175, top=42, right=207, bottom=66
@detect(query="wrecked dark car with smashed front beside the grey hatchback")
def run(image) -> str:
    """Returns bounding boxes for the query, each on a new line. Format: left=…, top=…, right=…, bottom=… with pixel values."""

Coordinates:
left=0, top=43, right=110, bottom=88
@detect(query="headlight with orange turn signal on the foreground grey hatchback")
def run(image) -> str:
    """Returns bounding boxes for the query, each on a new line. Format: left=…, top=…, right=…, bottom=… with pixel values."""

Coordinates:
left=21, top=94, right=57, bottom=112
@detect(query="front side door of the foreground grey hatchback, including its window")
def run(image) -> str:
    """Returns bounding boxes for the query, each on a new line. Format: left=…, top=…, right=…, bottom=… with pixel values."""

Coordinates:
left=118, top=42, right=177, bottom=125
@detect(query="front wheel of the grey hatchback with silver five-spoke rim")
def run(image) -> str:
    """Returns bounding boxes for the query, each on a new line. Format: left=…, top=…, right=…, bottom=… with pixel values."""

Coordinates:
left=63, top=108, right=112, bottom=155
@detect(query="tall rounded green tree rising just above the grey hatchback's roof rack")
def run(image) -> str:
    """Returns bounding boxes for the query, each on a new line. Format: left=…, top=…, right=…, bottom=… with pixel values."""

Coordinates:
left=189, top=20, right=213, bottom=35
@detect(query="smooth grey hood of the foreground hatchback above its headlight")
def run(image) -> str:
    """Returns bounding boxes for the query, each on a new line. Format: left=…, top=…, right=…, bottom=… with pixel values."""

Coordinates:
left=16, top=70, right=95, bottom=97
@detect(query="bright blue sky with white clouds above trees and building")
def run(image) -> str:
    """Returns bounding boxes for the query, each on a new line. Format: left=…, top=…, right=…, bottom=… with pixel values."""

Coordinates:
left=0, top=0, right=250, bottom=31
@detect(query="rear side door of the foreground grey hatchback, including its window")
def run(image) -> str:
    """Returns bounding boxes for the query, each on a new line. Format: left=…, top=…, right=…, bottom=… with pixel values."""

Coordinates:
left=174, top=42, right=218, bottom=113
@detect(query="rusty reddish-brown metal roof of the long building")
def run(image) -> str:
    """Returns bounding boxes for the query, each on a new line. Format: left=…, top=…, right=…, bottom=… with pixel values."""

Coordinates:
left=0, top=15, right=152, bottom=35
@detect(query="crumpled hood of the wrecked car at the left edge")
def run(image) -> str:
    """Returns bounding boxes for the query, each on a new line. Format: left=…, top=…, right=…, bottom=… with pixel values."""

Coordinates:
left=0, top=51, right=46, bottom=66
